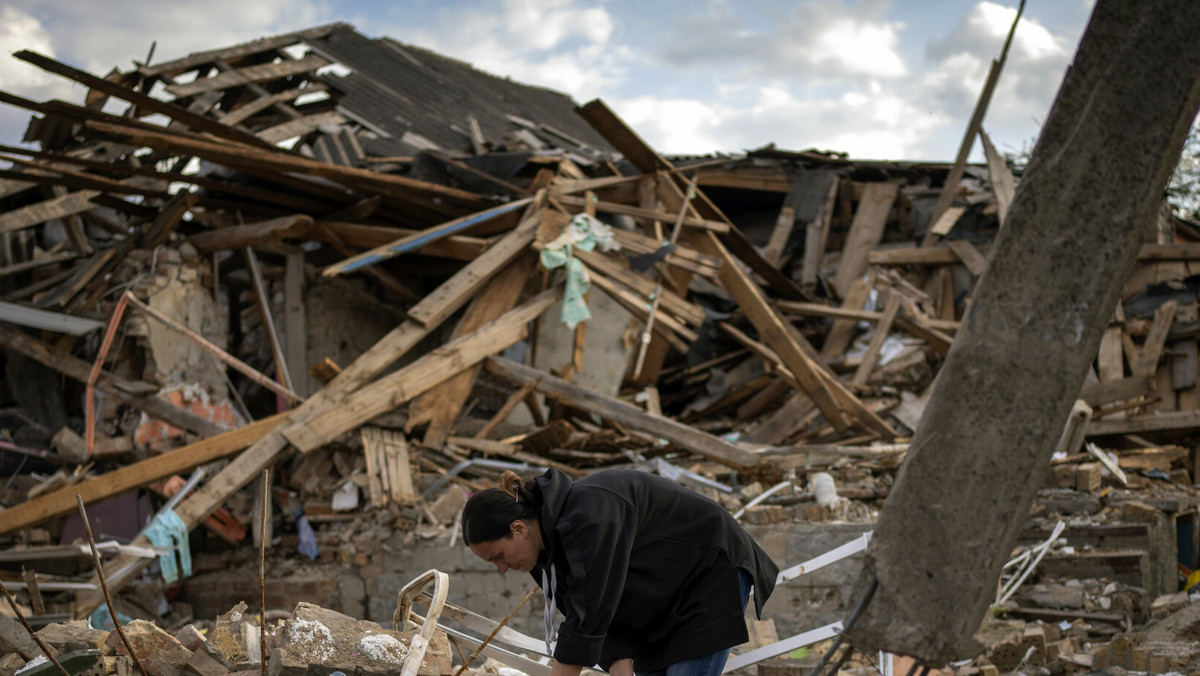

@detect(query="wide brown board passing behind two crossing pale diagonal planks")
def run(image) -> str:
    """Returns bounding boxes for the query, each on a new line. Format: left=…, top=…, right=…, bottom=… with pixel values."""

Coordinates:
left=404, top=251, right=536, bottom=448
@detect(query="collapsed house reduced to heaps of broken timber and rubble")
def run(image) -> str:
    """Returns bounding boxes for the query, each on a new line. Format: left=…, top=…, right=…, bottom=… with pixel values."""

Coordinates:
left=0, top=18, right=1200, bottom=674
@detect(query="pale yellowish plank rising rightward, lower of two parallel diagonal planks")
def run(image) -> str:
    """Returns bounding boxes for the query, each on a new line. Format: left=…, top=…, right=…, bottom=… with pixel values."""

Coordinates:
left=283, top=289, right=560, bottom=453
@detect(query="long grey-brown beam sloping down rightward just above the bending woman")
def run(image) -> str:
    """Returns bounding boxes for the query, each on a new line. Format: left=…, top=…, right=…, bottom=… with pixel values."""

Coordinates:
left=486, top=357, right=766, bottom=468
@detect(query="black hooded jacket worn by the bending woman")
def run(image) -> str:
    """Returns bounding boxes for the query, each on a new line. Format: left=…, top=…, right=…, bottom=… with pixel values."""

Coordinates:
left=532, top=469, right=779, bottom=671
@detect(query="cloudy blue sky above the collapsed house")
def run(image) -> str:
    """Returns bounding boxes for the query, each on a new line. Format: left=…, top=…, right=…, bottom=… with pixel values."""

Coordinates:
left=0, top=0, right=1094, bottom=161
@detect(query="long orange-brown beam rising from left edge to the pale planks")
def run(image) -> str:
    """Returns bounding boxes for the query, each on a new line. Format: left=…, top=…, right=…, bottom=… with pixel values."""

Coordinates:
left=0, top=415, right=282, bottom=534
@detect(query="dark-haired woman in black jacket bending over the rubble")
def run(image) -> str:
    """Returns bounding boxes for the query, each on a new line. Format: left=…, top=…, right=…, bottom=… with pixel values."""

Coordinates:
left=462, top=469, right=779, bottom=676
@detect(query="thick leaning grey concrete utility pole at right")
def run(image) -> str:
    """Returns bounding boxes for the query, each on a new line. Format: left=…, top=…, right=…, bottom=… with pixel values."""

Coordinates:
left=848, top=0, right=1200, bottom=664
